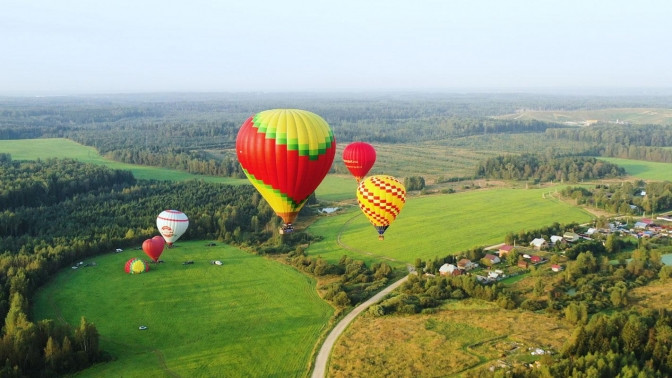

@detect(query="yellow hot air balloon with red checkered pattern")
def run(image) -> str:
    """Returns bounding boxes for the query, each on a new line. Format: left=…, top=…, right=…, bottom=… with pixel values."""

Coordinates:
left=357, top=175, right=406, bottom=240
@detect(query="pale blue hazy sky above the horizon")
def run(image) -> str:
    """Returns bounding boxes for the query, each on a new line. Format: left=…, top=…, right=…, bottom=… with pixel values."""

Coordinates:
left=0, top=0, right=672, bottom=95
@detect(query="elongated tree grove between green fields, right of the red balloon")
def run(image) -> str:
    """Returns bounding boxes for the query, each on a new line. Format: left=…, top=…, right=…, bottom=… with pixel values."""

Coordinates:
left=476, top=154, right=625, bottom=182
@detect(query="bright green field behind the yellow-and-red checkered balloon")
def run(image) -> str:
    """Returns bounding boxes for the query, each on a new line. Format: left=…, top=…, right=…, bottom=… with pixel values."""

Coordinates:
left=307, top=187, right=591, bottom=263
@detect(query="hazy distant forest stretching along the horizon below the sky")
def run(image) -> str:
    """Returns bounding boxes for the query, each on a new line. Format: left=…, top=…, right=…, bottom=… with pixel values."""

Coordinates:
left=0, top=93, right=672, bottom=177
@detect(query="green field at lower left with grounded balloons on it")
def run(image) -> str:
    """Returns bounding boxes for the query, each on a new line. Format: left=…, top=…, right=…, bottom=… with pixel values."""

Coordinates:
left=34, top=241, right=333, bottom=377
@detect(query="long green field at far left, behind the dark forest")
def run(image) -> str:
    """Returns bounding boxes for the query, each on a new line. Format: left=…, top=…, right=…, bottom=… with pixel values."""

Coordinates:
left=0, top=138, right=247, bottom=185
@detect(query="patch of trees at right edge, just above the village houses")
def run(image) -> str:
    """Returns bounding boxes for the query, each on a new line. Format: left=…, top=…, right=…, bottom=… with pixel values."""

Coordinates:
left=560, top=181, right=672, bottom=214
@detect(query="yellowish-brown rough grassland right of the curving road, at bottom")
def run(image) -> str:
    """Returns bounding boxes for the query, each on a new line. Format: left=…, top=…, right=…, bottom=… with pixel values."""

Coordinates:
left=328, top=300, right=571, bottom=377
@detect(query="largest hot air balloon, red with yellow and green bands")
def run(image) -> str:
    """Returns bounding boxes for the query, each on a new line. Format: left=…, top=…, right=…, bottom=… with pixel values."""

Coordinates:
left=236, top=109, right=336, bottom=233
